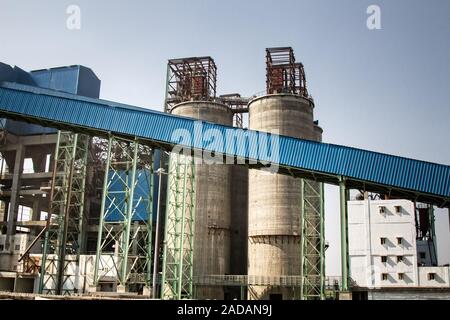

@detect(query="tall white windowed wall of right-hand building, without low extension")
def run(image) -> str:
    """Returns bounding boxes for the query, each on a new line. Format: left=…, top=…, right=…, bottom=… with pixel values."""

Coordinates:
left=348, top=200, right=418, bottom=287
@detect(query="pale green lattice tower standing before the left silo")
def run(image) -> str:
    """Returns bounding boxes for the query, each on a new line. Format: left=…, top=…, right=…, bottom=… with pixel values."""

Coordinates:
left=161, top=153, right=195, bottom=300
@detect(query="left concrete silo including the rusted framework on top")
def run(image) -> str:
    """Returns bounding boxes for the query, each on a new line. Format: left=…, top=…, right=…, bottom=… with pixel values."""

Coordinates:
left=165, top=57, right=233, bottom=299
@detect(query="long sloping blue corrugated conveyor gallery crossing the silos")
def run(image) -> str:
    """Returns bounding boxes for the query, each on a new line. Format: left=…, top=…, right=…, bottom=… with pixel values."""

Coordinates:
left=0, top=83, right=450, bottom=201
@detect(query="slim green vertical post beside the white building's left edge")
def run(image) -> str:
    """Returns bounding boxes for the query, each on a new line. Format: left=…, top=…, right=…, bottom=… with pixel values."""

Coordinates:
left=339, top=178, right=349, bottom=291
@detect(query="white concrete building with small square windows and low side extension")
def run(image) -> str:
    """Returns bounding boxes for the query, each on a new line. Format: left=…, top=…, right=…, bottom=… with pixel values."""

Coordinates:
left=348, top=199, right=450, bottom=298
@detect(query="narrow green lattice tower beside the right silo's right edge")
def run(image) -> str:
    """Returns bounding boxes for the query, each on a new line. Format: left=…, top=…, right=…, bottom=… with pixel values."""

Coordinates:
left=301, top=179, right=325, bottom=300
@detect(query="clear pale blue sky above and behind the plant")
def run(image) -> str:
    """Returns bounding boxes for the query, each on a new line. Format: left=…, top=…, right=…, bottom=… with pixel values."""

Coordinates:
left=0, top=0, right=450, bottom=274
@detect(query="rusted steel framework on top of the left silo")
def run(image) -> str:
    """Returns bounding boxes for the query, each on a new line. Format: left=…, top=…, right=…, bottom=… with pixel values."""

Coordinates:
left=164, top=57, right=217, bottom=112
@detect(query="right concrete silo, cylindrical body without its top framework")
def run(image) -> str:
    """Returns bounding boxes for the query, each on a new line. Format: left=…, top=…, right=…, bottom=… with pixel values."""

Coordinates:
left=248, top=94, right=315, bottom=299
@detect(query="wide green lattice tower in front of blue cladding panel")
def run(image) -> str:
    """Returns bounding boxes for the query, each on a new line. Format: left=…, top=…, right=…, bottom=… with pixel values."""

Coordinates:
left=93, top=135, right=154, bottom=287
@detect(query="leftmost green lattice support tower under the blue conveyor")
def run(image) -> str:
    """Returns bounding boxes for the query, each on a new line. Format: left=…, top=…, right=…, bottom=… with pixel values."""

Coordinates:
left=39, top=131, right=89, bottom=295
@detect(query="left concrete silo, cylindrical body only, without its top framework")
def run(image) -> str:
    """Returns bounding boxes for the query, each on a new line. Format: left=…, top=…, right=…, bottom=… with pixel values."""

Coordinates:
left=171, top=101, right=233, bottom=299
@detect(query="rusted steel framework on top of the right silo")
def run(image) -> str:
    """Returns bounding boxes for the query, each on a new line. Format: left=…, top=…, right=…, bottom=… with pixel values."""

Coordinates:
left=266, top=47, right=308, bottom=97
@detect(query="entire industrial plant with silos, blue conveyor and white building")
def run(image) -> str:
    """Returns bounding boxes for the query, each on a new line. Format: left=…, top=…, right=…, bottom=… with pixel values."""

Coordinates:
left=0, top=47, right=450, bottom=300
